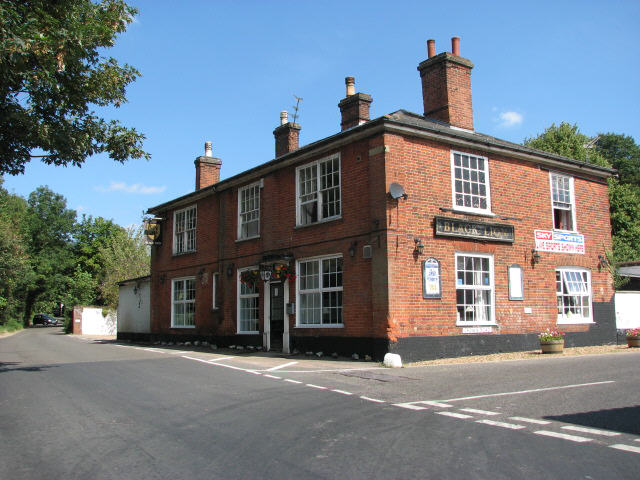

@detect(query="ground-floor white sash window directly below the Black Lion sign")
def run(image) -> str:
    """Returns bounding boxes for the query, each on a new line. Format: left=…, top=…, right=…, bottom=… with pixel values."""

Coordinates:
left=456, top=253, right=495, bottom=325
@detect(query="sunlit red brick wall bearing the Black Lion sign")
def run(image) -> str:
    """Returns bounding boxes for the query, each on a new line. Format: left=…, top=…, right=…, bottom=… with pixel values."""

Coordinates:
left=385, top=135, right=613, bottom=337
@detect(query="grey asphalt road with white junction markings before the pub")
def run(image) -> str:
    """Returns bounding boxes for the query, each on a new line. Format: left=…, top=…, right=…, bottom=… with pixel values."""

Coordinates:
left=0, top=328, right=640, bottom=480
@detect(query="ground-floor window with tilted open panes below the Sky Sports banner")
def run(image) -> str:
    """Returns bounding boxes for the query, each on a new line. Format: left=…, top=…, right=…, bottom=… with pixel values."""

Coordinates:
left=556, top=267, right=593, bottom=323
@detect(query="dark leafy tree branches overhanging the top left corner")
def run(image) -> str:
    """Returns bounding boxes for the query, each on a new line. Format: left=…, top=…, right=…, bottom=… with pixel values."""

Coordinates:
left=0, top=0, right=150, bottom=175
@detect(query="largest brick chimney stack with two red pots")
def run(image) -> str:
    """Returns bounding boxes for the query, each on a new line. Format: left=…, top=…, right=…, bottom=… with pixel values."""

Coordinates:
left=418, top=37, right=473, bottom=130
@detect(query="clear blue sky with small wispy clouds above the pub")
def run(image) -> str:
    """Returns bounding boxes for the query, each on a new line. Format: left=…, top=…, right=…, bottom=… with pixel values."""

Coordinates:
left=4, top=0, right=640, bottom=226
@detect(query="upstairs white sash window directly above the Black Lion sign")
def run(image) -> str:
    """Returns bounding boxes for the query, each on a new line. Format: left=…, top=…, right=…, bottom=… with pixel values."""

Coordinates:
left=451, top=152, right=491, bottom=213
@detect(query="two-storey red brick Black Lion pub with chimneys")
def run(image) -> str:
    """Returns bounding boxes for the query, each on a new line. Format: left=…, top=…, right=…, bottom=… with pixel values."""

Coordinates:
left=129, top=37, right=616, bottom=360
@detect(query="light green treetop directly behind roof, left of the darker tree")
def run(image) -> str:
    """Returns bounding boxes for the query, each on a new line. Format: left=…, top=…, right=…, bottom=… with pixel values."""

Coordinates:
left=524, top=122, right=611, bottom=167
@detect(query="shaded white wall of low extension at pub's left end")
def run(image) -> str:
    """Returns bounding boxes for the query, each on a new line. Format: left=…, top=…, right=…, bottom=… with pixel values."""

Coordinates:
left=118, top=279, right=151, bottom=333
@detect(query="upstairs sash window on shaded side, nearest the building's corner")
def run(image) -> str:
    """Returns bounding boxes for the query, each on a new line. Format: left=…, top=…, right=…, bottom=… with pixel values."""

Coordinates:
left=296, top=155, right=342, bottom=225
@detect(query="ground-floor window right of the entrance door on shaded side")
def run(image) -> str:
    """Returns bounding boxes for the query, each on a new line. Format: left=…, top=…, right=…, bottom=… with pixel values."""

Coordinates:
left=297, top=256, right=343, bottom=327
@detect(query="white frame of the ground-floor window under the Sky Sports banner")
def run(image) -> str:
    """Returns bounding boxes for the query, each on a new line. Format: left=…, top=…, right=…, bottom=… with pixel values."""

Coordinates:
left=555, top=267, right=594, bottom=325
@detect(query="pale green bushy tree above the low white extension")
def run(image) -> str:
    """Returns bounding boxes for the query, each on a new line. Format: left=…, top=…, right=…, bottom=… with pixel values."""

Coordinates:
left=99, top=228, right=151, bottom=307
